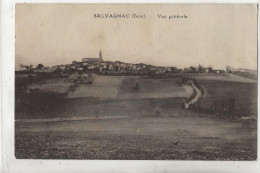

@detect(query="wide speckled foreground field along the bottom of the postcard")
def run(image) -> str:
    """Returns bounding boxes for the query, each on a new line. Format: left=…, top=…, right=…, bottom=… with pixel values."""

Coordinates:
left=15, top=116, right=256, bottom=160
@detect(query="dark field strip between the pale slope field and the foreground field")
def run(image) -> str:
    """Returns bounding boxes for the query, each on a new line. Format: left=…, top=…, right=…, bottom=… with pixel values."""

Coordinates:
left=15, top=94, right=183, bottom=119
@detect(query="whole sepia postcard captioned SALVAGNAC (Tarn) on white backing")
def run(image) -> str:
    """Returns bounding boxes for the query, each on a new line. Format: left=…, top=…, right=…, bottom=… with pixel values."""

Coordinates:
left=13, top=3, right=258, bottom=161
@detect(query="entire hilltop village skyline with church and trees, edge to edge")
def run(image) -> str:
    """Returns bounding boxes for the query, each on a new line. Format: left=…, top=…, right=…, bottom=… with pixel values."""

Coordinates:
left=16, top=50, right=255, bottom=77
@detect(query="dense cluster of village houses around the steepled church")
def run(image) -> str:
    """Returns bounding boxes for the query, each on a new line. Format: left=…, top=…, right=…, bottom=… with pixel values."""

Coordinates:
left=18, top=50, right=232, bottom=74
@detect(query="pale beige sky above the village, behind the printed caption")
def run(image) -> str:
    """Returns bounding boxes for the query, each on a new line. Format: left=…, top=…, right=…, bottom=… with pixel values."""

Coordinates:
left=15, top=4, right=257, bottom=69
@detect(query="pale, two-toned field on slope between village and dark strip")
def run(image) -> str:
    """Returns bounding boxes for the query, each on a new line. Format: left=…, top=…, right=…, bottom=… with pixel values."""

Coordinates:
left=67, top=76, right=193, bottom=99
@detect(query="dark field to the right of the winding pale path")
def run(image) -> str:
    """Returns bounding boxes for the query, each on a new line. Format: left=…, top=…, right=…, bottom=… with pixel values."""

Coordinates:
left=199, top=81, right=257, bottom=117
